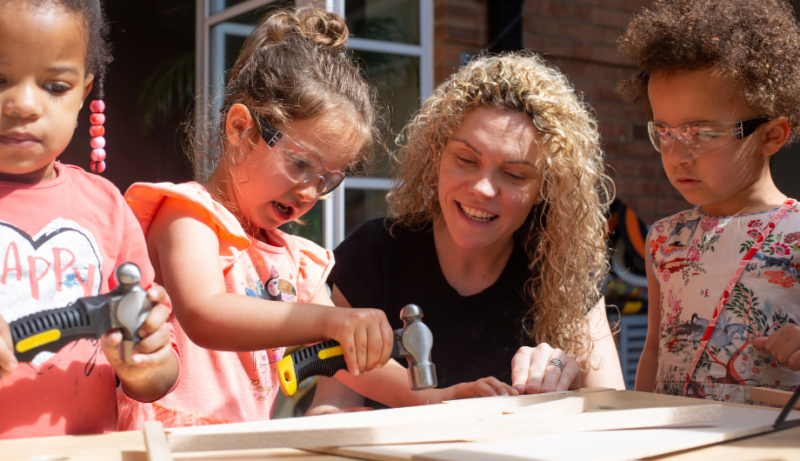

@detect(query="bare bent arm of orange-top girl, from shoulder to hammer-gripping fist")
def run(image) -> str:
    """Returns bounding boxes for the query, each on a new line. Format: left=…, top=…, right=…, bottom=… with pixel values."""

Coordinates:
left=147, top=198, right=393, bottom=375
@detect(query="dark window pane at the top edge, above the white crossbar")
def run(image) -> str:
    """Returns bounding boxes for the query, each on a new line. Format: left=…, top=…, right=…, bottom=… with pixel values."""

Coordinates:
left=344, top=0, right=419, bottom=45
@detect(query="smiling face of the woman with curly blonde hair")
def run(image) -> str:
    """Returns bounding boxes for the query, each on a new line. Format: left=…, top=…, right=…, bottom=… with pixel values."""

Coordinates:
left=438, top=106, right=542, bottom=249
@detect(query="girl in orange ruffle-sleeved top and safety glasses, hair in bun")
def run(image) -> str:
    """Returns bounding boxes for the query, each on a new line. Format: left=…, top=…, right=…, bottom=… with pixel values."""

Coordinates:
left=120, top=9, right=516, bottom=429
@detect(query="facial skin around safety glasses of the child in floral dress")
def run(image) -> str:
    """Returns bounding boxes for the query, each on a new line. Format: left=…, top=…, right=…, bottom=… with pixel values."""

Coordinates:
left=648, top=69, right=789, bottom=216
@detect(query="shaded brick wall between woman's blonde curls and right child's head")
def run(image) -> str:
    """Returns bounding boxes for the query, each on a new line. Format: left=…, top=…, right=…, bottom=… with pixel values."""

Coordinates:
left=523, top=0, right=690, bottom=223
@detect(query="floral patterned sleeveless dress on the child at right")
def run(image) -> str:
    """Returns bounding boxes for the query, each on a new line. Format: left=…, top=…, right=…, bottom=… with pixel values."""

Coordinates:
left=648, top=203, right=800, bottom=403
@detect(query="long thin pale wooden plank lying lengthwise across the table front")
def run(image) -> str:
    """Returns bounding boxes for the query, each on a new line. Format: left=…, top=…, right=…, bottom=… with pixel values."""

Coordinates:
left=164, top=404, right=722, bottom=452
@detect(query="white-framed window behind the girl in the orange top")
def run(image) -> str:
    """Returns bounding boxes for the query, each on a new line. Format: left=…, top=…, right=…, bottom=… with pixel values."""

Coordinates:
left=195, top=0, right=433, bottom=249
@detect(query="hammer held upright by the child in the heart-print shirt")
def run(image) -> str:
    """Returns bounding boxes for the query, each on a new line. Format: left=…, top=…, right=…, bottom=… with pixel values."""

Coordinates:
left=9, top=263, right=153, bottom=364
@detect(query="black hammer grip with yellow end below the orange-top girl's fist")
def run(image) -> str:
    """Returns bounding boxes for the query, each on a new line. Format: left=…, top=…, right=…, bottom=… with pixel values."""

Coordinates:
left=278, top=340, right=347, bottom=397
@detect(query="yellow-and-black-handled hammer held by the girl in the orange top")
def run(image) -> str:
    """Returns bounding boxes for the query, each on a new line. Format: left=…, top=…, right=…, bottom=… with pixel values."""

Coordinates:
left=278, top=304, right=438, bottom=397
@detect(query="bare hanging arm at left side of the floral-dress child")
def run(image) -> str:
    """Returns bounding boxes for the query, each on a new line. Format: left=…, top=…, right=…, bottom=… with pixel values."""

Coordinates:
left=636, top=238, right=661, bottom=392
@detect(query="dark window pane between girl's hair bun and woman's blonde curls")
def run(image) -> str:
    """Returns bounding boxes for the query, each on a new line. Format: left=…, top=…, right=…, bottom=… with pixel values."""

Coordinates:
left=353, top=51, right=420, bottom=177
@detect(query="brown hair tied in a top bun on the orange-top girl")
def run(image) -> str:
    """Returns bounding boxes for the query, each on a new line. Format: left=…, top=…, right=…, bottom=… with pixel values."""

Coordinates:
left=191, top=8, right=385, bottom=228
